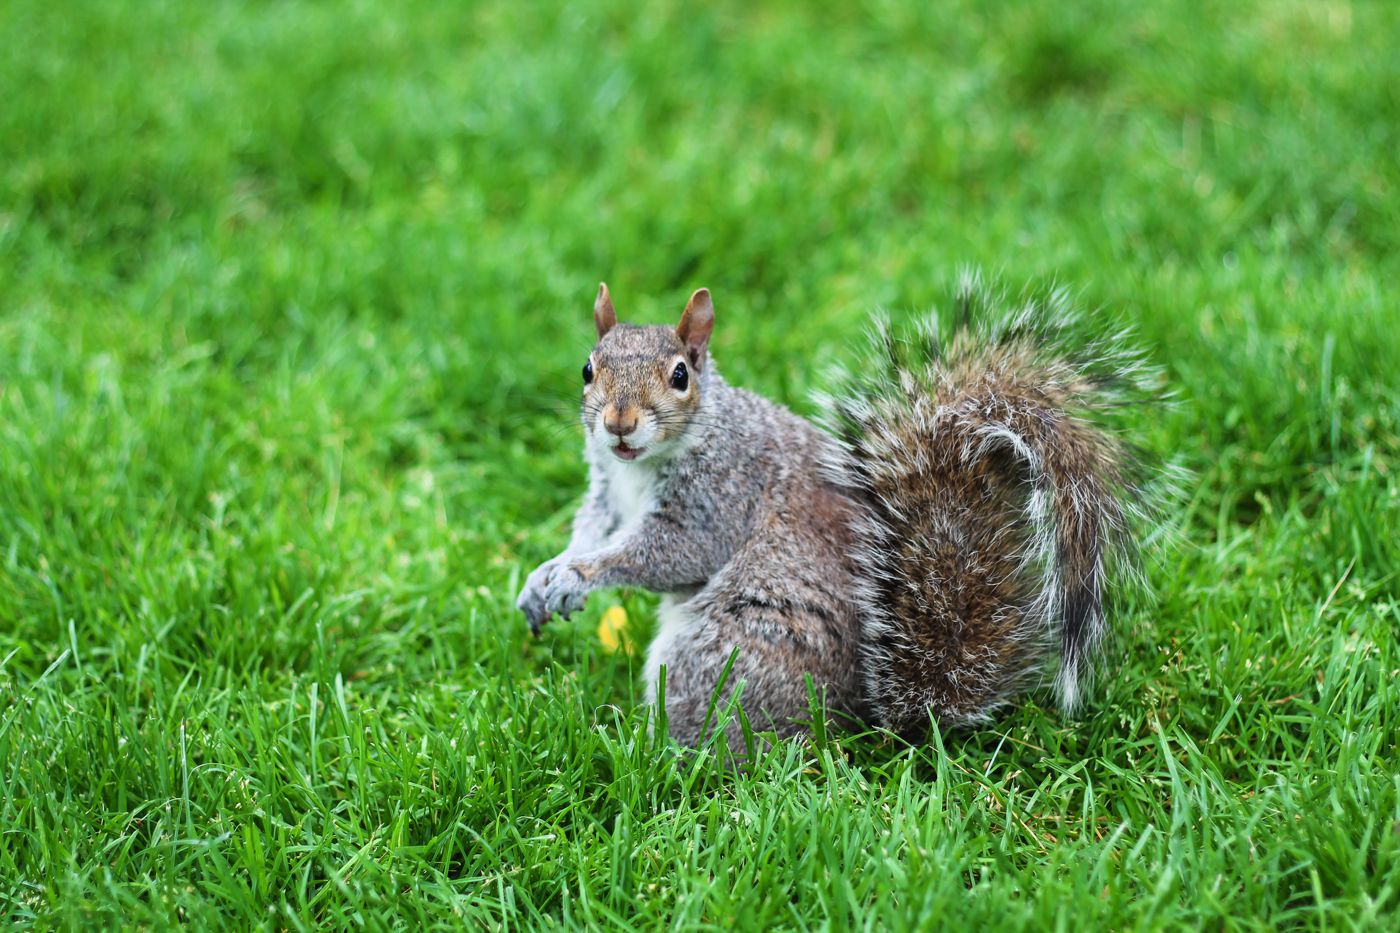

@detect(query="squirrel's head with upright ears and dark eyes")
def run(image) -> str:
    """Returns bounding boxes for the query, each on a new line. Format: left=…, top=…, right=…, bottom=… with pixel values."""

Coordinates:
left=582, top=284, right=714, bottom=461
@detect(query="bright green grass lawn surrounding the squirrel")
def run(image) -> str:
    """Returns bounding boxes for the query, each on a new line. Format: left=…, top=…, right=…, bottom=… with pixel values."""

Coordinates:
left=0, top=0, right=1400, bottom=929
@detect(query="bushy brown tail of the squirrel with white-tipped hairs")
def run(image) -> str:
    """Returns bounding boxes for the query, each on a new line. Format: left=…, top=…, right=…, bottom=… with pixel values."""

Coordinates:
left=823, top=277, right=1155, bottom=733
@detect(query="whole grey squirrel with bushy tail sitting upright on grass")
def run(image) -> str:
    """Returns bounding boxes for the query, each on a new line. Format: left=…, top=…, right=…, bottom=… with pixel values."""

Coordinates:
left=517, top=277, right=1152, bottom=748
